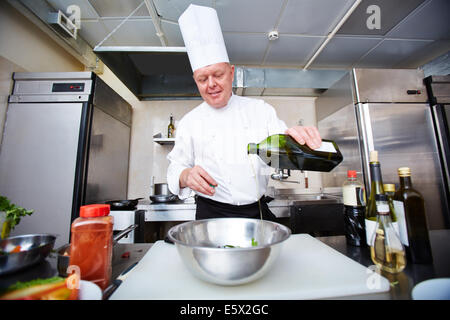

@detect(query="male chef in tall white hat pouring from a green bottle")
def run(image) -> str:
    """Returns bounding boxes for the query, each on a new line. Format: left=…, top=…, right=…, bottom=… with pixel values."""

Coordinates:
left=167, top=4, right=322, bottom=221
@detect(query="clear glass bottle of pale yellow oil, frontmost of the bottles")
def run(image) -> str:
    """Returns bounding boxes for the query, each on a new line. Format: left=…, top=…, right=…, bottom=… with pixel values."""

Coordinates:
left=370, top=194, right=406, bottom=273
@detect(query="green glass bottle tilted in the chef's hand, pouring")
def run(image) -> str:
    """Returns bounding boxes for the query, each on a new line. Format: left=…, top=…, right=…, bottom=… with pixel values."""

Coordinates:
left=247, top=134, right=343, bottom=172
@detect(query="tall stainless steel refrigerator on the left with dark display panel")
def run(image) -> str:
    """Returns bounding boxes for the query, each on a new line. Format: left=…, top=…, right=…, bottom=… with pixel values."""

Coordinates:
left=0, top=72, right=132, bottom=246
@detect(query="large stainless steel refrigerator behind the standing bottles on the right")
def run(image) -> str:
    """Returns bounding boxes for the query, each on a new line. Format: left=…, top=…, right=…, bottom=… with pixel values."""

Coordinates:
left=316, top=69, right=450, bottom=229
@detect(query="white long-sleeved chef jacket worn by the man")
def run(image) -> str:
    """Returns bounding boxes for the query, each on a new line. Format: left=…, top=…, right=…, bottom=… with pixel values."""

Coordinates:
left=167, top=94, right=287, bottom=205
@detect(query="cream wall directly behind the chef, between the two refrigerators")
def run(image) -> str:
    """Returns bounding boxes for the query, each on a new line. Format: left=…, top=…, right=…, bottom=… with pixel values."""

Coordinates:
left=128, top=97, right=321, bottom=199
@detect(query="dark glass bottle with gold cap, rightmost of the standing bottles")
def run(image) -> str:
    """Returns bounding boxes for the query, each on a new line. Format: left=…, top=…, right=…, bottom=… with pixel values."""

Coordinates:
left=394, top=167, right=433, bottom=264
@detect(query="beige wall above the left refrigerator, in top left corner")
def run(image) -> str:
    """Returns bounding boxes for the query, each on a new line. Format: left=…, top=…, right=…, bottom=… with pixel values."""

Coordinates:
left=0, top=1, right=84, bottom=144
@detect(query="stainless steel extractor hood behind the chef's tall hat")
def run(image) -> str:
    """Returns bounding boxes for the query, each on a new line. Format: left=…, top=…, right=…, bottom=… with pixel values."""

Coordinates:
left=94, top=47, right=345, bottom=100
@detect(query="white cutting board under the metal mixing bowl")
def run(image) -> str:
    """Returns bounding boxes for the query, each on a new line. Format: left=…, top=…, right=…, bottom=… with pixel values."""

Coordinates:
left=110, top=234, right=389, bottom=300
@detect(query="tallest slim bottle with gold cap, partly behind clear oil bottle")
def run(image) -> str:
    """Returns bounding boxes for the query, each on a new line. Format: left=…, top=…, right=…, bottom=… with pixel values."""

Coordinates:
left=365, top=150, right=384, bottom=246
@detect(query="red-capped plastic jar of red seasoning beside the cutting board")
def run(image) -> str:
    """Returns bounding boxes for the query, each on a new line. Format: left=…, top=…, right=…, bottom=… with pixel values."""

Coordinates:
left=69, top=204, right=114, bottom=290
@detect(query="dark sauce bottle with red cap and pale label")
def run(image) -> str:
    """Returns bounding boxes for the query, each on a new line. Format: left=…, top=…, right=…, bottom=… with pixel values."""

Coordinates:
left=342, top=170, right=366, bottom=247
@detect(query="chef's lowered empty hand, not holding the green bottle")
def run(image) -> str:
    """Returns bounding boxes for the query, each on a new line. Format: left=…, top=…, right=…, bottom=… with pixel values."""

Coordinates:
left=180, top=166, right=217, bottom=196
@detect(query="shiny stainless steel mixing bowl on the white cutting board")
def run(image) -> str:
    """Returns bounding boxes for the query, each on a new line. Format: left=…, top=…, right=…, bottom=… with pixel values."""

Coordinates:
left=168, top=218, right=291, bottom=286
